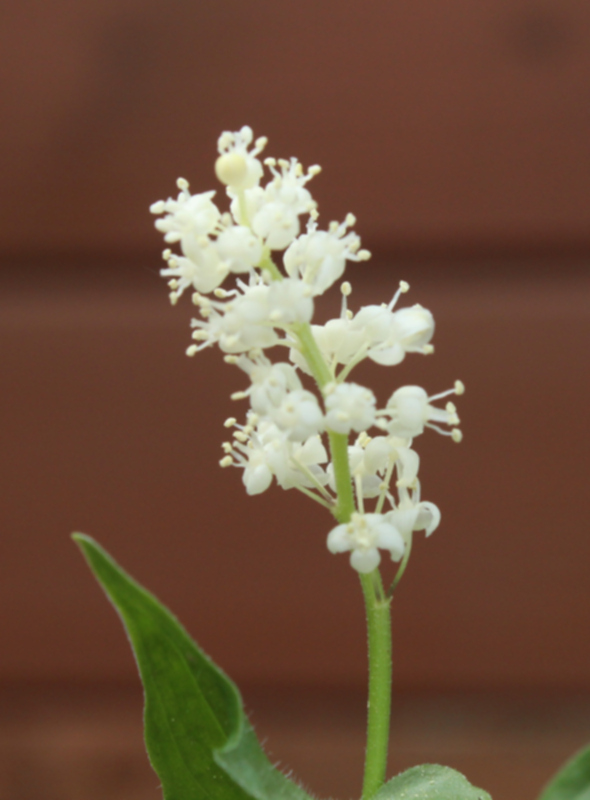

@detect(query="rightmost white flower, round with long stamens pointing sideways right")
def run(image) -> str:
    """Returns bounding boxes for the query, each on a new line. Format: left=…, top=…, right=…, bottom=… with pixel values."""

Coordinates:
left=377, top=381, right=464, bottom=441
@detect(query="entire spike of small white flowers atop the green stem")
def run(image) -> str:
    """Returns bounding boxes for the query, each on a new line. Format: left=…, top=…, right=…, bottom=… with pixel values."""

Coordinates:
left=151, top=127, right=464, bottom=573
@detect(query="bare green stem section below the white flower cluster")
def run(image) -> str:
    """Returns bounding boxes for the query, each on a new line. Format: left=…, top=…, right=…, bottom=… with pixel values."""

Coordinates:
left=360, top=569, right=392, bottom=800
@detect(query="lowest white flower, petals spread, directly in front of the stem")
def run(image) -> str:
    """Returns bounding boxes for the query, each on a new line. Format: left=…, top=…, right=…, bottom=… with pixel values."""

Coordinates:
left=327, top=513, right=405, bottom=573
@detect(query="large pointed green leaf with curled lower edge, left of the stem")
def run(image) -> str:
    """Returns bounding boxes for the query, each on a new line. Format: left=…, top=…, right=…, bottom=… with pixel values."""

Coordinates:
left=73, top=533, right=309, bottom=800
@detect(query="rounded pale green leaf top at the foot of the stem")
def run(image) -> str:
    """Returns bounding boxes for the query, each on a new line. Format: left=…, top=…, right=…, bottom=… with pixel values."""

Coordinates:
left=372, top=764, right=491, bottom=800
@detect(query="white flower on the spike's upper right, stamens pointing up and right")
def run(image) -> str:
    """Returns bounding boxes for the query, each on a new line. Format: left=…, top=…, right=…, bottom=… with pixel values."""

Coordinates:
left=283, top=214, right=371, bottom=295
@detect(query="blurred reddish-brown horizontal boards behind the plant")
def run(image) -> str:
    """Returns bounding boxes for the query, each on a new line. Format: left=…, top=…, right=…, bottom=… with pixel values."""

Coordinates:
left=0, top=0, right=590, bottom=800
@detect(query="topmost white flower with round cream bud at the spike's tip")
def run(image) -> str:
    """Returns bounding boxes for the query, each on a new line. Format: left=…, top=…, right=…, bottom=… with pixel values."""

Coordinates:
left=215, top=125, right=267, bottom=191
